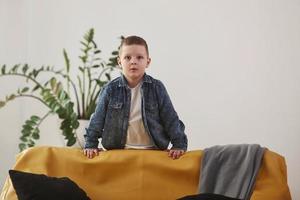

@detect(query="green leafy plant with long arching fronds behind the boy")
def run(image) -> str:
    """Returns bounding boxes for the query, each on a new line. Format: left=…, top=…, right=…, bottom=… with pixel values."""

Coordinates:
left=0, top=29, right=123, bottom=151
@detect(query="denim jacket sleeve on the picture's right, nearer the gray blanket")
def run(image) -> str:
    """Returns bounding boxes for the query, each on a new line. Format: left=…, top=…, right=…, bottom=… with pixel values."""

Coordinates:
left=157, top=81, right=188, bottom=150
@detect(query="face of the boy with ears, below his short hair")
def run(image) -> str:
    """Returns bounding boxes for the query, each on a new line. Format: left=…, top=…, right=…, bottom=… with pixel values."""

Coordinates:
left=118, top=45, right=151, bottom=82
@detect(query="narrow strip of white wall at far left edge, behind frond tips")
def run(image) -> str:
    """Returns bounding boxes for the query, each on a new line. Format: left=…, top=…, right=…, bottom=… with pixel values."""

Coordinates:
left=0, top=0, right=28, bottom=188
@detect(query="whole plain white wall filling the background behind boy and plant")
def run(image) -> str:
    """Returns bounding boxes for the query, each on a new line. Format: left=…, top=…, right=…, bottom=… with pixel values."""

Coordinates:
left=0, top=0, right=300, bottom=199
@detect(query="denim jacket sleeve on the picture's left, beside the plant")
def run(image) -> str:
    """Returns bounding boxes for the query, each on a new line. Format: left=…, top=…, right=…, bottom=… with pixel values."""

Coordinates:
left=84, top=86, right=109, bottom=148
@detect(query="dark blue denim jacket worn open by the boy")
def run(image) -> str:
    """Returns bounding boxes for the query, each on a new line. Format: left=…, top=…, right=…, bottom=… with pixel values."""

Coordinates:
left=85, top=74, right=187, bottom=150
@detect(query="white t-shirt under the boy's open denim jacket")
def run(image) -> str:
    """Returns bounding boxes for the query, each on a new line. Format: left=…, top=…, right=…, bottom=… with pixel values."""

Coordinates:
left=125, top=82, right=154, bottom=149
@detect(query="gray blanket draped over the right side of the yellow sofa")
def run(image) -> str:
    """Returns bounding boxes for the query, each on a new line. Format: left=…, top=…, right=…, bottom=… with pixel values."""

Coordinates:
left=199, top=144, right=265, bottom=200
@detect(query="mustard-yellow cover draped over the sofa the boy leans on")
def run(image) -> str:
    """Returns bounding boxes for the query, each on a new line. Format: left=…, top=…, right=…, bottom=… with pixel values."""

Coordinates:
left=0, top=147, right=291, bottom=200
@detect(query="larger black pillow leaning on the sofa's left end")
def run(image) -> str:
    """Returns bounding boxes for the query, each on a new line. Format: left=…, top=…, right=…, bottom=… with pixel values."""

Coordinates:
left=9, top=170, right=90, bottom=200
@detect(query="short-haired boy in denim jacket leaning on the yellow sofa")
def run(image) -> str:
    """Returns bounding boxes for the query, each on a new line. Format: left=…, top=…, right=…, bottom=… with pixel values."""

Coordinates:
left=84, top=36, right=187, bottom=159
